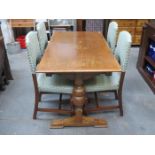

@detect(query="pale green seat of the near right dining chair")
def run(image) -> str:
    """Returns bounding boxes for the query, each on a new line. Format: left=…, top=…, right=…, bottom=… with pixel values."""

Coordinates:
left=85, top=72, right=120, bottom=92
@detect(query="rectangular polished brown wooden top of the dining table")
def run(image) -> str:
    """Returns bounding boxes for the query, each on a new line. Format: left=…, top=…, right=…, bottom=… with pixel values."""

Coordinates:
left=37, top=31, right=121, bottom=73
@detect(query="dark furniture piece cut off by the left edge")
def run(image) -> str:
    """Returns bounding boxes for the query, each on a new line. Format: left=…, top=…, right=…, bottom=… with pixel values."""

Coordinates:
left=0, top=25, right=13, bottom=90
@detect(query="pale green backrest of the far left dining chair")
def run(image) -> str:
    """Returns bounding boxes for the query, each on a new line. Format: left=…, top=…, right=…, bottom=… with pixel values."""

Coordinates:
left=36, top=22, right=48, bottom=55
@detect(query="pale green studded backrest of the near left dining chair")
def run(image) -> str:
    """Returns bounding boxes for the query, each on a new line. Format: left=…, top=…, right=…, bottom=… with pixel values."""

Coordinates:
left=26, top=32, right=41, bottom=73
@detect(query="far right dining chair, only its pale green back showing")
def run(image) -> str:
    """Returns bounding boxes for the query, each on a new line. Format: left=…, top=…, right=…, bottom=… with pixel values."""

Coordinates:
left=107, top=21, right=118, bottom=54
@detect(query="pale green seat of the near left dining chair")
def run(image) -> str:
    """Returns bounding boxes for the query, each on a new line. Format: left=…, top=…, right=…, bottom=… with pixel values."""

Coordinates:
left=37, top=73, right=73, bottom=94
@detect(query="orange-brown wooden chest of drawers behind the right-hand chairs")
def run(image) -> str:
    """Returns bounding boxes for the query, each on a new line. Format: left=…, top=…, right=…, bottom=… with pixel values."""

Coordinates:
left=114, top=19, right=149, bottom=45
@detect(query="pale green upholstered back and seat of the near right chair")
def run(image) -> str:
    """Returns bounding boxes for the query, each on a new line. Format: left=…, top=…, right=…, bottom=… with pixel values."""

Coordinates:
left=85, top=31, right=132, bottom=92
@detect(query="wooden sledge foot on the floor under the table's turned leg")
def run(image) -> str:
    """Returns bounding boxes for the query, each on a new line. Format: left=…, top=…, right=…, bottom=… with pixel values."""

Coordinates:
left=50, top=116, right=107, bottom=128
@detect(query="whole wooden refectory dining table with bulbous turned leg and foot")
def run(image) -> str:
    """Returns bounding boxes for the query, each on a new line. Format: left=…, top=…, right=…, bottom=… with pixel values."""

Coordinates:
left=37, top=31, right=121, bottom=128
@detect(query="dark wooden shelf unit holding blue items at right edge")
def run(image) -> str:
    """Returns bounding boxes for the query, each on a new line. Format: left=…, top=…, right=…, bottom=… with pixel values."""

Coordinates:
left=137, top=23, right=155, bottom=93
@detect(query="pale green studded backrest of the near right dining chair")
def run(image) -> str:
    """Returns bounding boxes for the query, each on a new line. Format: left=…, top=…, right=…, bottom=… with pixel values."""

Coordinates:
left=115, top=31, right=132, bottom=72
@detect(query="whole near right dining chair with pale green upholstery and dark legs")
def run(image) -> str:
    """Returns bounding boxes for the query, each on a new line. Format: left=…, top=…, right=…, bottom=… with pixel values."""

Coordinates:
left=85, top=31, right=132, bottom=116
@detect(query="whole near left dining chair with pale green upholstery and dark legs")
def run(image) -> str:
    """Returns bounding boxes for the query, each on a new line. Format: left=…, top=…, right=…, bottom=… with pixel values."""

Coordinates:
left=26, top=31, right=73, bottom=119
